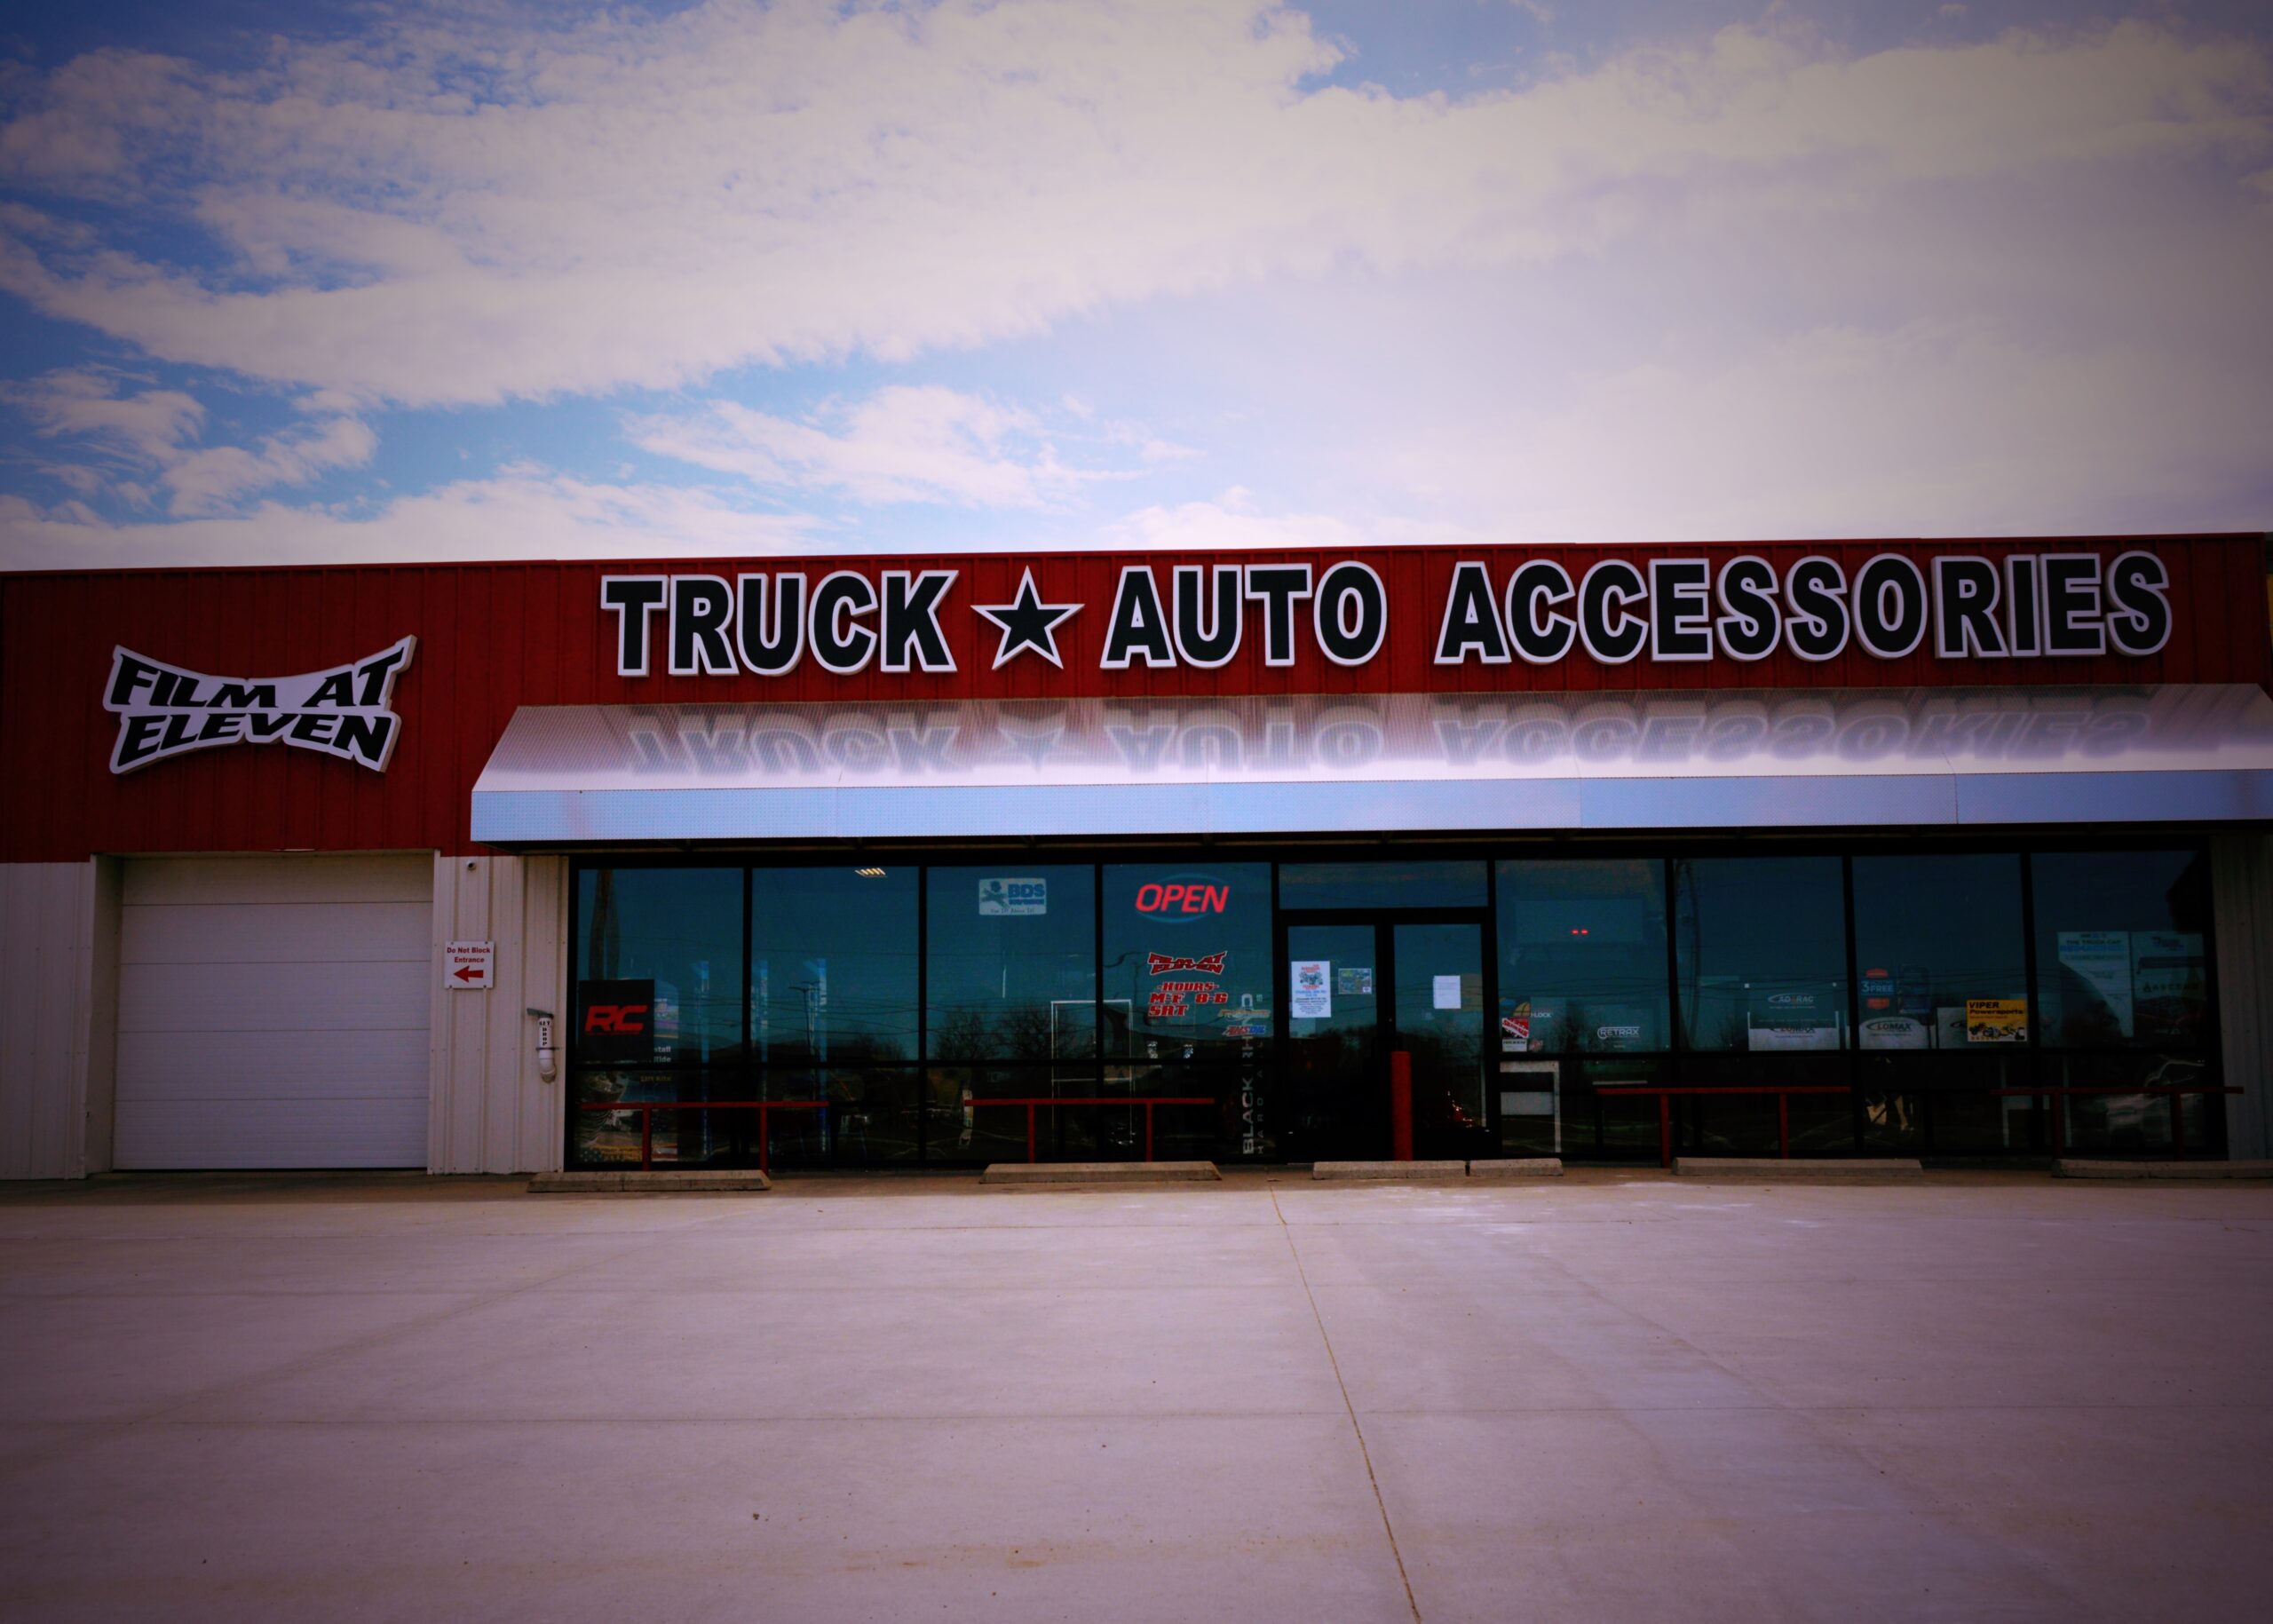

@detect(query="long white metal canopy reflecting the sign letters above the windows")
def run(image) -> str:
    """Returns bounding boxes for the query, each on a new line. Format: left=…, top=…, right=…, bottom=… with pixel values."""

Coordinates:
left=472, top=685, right=2273, bottom=846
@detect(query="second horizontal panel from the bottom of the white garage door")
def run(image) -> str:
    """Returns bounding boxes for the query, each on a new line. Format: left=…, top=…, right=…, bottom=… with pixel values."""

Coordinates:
left=118, top=1030, right=427, bottom=1101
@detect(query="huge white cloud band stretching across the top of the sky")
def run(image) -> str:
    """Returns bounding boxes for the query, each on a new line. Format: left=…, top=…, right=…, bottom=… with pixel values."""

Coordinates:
left=0, top=0, right=2273, bottom=402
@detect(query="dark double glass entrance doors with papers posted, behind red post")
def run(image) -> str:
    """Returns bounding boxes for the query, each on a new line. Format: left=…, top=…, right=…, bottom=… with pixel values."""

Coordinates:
left=1278, top=915, right=1493, bottom=1162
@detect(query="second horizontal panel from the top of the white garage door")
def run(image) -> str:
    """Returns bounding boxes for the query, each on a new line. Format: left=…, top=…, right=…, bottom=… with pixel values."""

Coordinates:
left=118, top=903, right=434, bottom=964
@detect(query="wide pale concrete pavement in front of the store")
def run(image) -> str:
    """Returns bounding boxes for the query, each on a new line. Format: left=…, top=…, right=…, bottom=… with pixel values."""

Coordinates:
left=0, top=1171, right=2273, bottom=1624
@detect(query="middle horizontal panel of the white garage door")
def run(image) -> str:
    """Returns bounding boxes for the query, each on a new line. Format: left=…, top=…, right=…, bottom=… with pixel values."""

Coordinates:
left=118, top=963, right=432, bottom=1035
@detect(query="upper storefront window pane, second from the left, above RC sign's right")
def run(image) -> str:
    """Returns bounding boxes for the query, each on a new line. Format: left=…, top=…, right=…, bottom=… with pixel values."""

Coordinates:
left=750, top=864, right=918, bottom=1066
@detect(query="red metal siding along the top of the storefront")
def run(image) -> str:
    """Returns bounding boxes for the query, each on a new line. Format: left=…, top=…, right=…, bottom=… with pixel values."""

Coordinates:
left=0, top=537, right=2273, bottom=862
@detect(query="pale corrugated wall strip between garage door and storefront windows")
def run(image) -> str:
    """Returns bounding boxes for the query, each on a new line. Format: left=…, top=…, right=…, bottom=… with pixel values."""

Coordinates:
left=427, top=858, right=568, bottom=1174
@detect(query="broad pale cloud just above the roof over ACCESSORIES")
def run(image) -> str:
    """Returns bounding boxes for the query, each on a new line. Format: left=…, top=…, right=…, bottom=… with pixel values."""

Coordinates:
left=1382, top=321, right=2273, bottom=543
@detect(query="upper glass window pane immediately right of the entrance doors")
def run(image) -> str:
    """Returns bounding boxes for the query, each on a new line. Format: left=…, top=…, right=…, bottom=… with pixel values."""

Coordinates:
left=1498, top=858, right=1666, bottom=1056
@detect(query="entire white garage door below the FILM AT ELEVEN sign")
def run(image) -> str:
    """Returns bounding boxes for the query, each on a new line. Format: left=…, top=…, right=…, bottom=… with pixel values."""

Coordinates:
left=111, top=853, right=434, bottom=1167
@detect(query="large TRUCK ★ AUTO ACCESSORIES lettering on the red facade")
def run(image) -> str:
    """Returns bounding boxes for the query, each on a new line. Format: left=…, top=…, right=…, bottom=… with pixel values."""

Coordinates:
left=600, top=551, right=2171, bottom=677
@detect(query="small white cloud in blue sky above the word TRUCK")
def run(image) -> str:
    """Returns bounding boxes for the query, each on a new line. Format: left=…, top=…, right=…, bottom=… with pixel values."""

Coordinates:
left=628, top=384, right=1116, bottom=510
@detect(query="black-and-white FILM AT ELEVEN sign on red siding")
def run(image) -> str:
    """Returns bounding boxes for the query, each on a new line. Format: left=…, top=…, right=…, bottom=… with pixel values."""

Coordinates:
left=102, top=637, right=418, bottom=773
